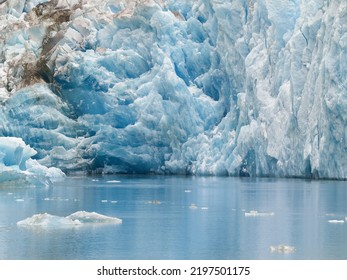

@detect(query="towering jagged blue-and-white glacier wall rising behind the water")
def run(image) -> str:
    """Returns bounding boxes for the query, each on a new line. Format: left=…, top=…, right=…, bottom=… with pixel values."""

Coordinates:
left=0, top=0, right=347, bottom=179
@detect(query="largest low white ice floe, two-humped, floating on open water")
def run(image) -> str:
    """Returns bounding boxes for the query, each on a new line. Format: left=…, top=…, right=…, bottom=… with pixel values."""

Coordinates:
left=17, top=211, right=122, bottom=228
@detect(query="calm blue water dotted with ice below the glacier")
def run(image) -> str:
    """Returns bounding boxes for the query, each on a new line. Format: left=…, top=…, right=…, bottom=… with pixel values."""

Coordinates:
left=0, top=176, right=347, bottom=260
